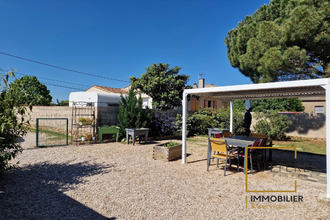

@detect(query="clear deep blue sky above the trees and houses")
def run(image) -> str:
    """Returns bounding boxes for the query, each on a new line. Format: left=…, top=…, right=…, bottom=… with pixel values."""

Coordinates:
left=0, top=0, right=269, bottom=101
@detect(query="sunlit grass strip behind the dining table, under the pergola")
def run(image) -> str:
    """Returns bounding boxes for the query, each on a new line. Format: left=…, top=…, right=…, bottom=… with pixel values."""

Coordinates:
left=273, top=138, right=326, bottom=155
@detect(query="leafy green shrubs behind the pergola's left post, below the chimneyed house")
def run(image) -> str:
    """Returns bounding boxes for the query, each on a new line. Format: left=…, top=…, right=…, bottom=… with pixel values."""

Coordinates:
left=176, top=108, right=244, bottom=136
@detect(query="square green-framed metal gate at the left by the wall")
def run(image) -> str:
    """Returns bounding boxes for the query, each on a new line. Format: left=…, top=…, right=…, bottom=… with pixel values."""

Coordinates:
left=36, top=118, right=68, bottom=147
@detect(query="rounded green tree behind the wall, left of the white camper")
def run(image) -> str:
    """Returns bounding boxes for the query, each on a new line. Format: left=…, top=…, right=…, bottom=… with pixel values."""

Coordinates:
left=10, top=76, right=52, bottom=105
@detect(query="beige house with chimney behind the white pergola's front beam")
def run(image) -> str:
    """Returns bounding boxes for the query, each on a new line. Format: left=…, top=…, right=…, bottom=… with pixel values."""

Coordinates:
left=187, top=79, right=228, bottom=111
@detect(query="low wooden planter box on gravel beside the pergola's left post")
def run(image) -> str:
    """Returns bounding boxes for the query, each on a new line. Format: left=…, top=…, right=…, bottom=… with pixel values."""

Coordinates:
left=153, top=144, right=182, bottom=161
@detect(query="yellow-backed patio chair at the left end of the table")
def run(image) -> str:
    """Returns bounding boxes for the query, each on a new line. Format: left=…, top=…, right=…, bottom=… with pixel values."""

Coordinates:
left=206, top=138, right=239, bottom=176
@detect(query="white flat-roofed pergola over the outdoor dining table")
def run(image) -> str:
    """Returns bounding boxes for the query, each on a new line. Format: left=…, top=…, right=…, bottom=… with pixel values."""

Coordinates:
left=182, top=78, right=330, bottom=198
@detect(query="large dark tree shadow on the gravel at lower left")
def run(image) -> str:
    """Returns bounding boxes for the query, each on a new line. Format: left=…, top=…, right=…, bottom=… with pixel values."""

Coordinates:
left=0, top=163, right=115, bottom=219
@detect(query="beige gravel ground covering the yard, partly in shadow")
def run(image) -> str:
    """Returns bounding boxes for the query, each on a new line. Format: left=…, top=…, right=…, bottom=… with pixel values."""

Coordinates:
left=0, top=133, right=330, bottom=219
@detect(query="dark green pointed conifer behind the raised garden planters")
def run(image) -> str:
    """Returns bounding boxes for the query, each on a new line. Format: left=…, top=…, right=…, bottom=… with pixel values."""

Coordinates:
left=118, top=87, right=151, bottom=137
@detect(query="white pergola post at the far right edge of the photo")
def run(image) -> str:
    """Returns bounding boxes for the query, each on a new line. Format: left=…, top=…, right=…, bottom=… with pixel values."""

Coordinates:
left=325, top=84, right=330, bottom=198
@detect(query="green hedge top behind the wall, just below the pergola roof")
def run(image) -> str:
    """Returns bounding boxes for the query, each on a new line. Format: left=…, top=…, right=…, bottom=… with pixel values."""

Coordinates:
left=234, top=98, right=304, bottom=112
